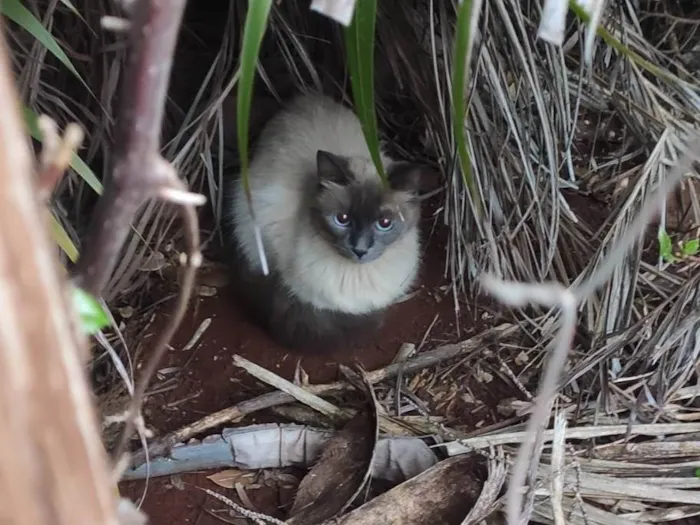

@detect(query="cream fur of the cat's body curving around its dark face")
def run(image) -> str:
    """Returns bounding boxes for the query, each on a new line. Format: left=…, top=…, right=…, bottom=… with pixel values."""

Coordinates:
left=233, top=95, right=420, bottom=314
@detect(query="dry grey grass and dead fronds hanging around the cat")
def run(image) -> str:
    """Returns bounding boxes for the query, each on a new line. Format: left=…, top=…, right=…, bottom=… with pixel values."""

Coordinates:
left=6, top=0, right=700, bottom=524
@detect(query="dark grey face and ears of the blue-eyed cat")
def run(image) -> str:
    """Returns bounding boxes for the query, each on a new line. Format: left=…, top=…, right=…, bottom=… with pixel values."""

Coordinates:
left=311, top=151, right=421, bottom=263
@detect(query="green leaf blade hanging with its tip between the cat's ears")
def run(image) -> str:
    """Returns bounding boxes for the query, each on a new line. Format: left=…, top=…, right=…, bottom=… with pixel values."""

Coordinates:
left=345, top=0, right=387, bottom=184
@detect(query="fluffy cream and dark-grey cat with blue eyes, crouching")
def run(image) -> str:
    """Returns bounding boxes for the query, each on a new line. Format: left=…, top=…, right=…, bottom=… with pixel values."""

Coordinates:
left=227, top=94, right=423, bottom=352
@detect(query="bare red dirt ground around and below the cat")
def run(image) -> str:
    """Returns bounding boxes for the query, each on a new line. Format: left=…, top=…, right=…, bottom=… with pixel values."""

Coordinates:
left=120, top=198, right=513, bottom=525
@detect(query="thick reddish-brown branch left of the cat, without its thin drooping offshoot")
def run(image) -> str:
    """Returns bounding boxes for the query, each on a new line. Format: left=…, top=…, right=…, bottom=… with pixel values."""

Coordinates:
left=76, top=0, right=186, bottom=296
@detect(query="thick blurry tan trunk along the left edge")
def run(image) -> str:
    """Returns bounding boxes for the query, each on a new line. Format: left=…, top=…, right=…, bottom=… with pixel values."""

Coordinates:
left=0, top=21, right=117, bottom=525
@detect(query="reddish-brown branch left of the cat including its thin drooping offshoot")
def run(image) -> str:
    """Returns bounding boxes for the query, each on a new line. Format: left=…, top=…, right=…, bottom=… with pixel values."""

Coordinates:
left=69, top=0, right=202, bottom=461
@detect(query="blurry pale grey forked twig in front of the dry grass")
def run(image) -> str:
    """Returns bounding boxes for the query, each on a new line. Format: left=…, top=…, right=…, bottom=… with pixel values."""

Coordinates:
left=484, top=136, right=700, bottom=525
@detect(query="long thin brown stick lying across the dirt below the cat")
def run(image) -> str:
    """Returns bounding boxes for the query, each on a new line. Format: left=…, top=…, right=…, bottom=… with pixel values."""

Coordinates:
left=131, top=324, right=519, bottom=467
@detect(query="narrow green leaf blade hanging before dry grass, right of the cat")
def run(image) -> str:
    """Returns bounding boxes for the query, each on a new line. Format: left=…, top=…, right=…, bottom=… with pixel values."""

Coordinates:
left=452, top=0, right=481, bottom=217
